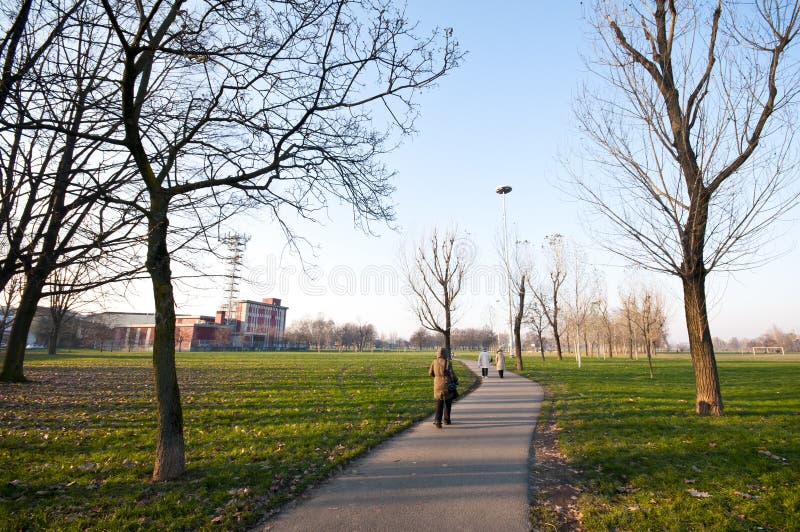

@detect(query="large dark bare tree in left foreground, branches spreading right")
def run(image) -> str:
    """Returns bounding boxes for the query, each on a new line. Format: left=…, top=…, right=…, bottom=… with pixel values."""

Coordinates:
left=87, top=0, right=460, bottom=480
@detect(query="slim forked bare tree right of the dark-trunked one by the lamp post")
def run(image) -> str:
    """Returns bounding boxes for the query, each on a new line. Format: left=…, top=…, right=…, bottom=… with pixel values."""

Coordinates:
left=529, top=233, right=567, bottom=360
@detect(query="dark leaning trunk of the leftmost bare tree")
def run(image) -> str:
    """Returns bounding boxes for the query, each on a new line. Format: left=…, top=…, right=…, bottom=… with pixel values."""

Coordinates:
left=0, top=274, right=47, bottom=382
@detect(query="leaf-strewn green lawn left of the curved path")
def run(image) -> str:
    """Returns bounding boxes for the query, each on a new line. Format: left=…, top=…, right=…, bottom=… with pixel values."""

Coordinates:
left=0, top=352, right=476, bottom=530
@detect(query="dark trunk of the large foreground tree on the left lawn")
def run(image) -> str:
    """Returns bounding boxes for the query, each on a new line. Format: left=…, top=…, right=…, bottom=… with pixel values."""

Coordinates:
left=147, top=195, right=186, bottom=481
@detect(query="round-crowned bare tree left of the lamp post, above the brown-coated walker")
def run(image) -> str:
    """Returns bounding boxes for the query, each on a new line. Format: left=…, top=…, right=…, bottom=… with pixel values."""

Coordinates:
left=403, top=229, right=472, bottom=350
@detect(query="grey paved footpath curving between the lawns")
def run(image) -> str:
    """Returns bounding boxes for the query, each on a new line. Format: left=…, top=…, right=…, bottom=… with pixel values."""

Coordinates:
left=258, top=359, right=542, bottom=532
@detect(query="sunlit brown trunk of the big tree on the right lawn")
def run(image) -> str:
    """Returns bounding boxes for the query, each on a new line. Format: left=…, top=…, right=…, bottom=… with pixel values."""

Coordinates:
left=682, top=273, right=724, bottom=416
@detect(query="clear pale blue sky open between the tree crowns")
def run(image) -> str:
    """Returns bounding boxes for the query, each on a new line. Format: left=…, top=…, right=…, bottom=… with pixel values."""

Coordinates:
left=120, top=0, right=800, bottom=342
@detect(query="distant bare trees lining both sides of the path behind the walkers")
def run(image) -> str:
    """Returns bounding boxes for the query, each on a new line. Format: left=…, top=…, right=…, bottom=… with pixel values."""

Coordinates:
left=403, top=229, right=667, bottom=369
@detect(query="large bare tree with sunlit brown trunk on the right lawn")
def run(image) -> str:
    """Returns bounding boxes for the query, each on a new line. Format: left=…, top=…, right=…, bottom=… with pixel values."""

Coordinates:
left=576, top=0, right=800, bottom=415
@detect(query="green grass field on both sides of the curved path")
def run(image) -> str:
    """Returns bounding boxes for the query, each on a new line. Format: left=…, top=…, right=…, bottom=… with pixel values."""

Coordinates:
left=0, top=353, right=800, bottom=530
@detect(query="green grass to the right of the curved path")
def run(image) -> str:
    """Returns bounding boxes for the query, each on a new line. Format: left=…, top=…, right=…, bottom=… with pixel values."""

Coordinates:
left=525, top=355, right=800, bottom=530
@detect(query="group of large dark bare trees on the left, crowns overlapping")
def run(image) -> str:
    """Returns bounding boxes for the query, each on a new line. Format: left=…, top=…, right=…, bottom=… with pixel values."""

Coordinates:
left=0, top=0, right=461, bottom=480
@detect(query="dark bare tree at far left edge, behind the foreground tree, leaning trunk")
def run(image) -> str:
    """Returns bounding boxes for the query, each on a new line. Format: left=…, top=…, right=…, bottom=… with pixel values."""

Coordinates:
left=0, top=3, right=141, bottom=382
